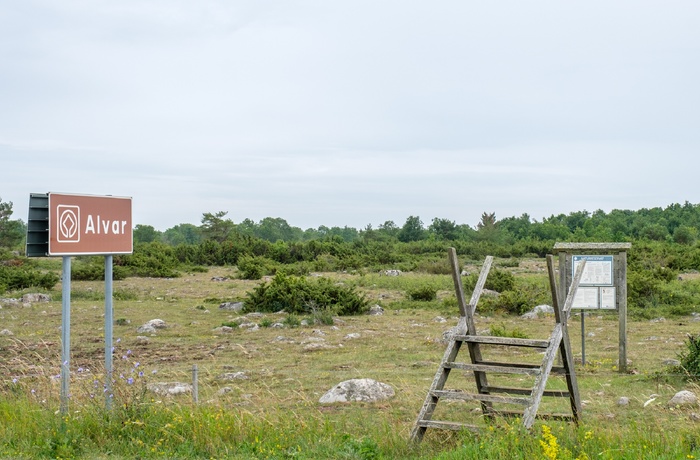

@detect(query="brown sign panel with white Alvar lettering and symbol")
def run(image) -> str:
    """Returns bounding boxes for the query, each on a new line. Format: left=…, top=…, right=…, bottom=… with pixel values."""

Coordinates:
left=49, top=193, right=134, bottom=256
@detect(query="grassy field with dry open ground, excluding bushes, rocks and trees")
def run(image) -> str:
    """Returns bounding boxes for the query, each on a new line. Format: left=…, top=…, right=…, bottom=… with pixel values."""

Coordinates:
left=0, top=260, right=700, bottom=459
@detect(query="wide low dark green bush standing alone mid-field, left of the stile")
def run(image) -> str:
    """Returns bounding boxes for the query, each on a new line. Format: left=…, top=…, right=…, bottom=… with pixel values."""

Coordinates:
left=245, top=273, right=369, bottom=315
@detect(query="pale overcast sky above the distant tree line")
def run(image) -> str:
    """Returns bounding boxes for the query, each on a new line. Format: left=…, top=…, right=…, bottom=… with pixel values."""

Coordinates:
left=0, top=0, right=700, bottom=230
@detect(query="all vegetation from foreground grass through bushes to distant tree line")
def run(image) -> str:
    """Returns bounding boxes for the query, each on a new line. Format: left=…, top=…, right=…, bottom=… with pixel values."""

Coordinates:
left=0, top=203, right=700, bottom=460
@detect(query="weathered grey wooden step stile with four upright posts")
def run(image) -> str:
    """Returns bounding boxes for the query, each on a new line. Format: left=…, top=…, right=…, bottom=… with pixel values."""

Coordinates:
left=411, top=248, right=585, bottom=442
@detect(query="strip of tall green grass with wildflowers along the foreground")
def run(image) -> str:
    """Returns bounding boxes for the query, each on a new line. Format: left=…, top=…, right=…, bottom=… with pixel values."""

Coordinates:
left=0, top=384, right=700, bottom=460
